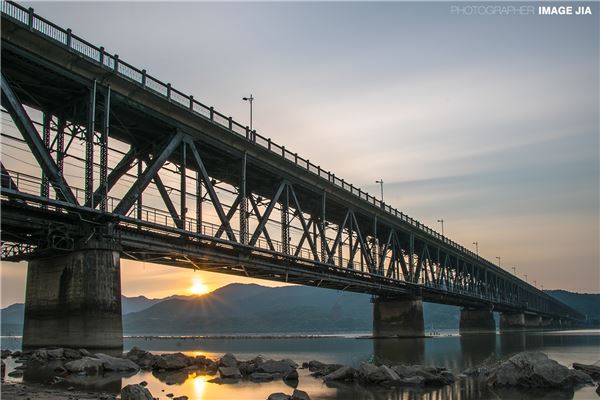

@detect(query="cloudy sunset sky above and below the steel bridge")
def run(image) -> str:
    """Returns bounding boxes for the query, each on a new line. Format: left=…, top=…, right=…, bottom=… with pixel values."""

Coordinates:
left=1, top=2, right=600, bottom=306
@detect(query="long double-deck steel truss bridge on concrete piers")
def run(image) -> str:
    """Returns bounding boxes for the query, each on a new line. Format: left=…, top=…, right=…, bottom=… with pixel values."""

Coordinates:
left=1, top=1, right=583, bottom=348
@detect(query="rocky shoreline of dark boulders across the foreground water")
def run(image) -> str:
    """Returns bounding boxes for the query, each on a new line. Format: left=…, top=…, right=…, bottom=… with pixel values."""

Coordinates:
left=1, top=347, right=600, bottom=400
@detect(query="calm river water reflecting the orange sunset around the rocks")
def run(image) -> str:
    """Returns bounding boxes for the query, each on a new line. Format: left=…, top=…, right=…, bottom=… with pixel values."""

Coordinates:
left=2, top=330, right=600, bottom=400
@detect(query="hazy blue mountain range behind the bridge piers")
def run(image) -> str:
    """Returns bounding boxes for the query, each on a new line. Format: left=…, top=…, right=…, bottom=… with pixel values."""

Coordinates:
left=0, top=284, right=600, bottom=335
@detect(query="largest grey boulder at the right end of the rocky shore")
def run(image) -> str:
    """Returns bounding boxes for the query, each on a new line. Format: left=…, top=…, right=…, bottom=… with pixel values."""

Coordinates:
left=488, top=352, right=592, bottom=388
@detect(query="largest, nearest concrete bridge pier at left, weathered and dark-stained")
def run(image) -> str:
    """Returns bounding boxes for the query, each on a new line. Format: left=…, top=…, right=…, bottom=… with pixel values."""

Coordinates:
left=23, top=240, right=123, bottom=350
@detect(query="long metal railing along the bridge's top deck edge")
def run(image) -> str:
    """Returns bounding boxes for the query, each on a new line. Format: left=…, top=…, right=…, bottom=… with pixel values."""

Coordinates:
left=1, top=0, right=520, bottom=286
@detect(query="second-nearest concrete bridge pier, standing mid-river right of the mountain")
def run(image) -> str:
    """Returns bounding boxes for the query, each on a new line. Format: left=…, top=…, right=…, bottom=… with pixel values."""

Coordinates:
left=373, top=297, right=425, bottom=337
